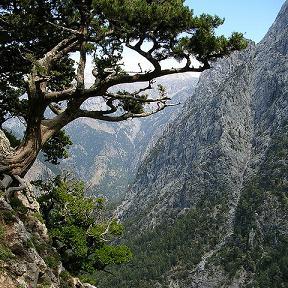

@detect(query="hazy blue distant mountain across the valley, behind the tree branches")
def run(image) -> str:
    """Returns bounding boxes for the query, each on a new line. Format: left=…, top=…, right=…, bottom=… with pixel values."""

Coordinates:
left=20, top=73, right=198, bottom=200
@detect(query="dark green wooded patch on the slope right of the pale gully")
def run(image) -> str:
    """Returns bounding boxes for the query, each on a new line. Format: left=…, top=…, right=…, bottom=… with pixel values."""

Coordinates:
left=218, top=124, right=288, bottom=288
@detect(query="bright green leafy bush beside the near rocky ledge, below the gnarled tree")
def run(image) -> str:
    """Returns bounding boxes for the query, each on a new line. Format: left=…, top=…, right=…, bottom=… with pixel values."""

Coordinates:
left=38, top=176, right=131, bottom=275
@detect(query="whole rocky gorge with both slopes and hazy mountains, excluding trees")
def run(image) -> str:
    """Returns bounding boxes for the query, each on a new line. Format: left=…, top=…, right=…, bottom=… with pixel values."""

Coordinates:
left=0, top=1, right=288, bottom=288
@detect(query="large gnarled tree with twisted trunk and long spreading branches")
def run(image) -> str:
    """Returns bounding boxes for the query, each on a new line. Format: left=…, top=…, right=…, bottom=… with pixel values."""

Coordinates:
left=0, top=0, right=247, bottom=176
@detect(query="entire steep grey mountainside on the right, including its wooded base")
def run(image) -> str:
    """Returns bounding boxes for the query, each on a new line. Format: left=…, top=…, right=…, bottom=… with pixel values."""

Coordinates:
left=100, top=1, right=288, bottom=288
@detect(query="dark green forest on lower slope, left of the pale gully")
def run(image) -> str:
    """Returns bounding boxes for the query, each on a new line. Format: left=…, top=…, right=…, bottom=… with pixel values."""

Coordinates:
left=95, top=196, right=227, bottom=288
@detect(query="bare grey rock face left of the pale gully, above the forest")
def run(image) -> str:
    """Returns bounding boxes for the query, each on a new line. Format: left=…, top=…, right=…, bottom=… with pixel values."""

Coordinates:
left=117, top=47, right=254, bottom=227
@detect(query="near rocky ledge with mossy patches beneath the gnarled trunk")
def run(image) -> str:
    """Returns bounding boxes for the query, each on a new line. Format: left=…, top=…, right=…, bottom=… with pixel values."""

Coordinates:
left=0, top=130, right=94, bottom=288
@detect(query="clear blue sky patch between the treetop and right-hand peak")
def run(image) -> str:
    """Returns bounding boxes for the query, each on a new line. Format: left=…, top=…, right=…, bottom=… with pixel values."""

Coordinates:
left=185, top=0, right=285, bottom=43
